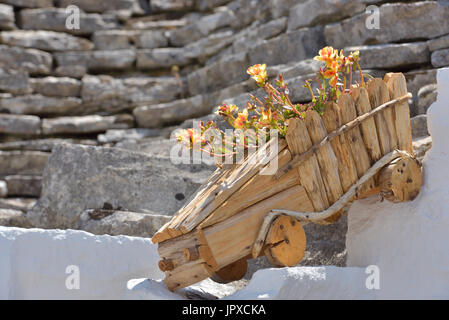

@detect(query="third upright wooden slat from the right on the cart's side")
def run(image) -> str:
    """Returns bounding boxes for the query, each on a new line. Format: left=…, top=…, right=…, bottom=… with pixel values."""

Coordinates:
left=351, top=87, right=382, bottom=163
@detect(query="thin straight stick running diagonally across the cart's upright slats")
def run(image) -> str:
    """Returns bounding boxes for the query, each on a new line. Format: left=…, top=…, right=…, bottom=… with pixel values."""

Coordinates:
left=275, top=93, right=412, bottom=179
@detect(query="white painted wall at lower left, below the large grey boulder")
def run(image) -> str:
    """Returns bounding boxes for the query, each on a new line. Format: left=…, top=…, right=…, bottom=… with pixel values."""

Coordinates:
left=0, top=227, right=163, bottom=299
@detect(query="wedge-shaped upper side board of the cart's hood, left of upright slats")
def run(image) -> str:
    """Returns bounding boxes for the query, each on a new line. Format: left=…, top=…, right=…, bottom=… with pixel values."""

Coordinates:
left=200, top=149, right=299, bottom=229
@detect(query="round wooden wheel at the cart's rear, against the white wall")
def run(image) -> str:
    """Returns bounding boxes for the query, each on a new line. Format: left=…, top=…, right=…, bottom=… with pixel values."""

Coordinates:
left=379, top=156, right=422, bottom=202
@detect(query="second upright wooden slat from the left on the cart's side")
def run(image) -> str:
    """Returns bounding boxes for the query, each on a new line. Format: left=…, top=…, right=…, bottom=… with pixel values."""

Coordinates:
left=304, top=110, right=343, bottom=205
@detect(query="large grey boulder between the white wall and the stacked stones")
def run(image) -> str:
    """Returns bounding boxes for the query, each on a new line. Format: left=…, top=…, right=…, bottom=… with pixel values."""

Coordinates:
left=28, top=144, right=212, bottom=228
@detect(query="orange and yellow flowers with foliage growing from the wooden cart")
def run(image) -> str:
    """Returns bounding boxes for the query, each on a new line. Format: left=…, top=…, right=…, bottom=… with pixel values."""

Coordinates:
left=177, top=47, right=364, bottom=161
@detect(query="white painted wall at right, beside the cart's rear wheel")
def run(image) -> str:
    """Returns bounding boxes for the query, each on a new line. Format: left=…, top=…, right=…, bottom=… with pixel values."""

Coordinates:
left=346, top=68, right=449, bottom=299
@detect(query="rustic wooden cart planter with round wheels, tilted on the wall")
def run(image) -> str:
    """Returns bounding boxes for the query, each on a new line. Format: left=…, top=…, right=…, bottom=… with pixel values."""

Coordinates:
left=152, top=73, right=421, bottom=291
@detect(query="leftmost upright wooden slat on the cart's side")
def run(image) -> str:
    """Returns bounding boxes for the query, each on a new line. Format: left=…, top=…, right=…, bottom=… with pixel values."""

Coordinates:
left=285, top=118, right=329, bottom=211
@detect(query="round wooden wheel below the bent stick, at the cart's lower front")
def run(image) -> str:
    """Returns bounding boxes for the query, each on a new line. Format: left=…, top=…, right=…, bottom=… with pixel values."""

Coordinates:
left=265, top=216, right=306, bottom=267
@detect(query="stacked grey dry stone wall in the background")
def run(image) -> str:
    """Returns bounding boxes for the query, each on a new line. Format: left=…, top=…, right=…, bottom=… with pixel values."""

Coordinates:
left=0, top=0, right=440, bottom=218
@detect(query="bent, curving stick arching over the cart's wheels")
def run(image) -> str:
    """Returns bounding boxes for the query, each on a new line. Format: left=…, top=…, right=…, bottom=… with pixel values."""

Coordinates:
left=252, top=150, right=410, bottom=257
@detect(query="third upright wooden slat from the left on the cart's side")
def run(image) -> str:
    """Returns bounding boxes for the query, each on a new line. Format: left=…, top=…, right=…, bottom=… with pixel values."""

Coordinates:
left=322, top=102, right=358, bottom=192
